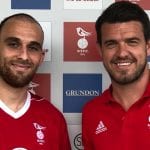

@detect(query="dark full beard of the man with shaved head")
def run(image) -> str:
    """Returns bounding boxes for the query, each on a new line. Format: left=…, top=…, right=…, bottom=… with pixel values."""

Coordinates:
left=0, top=59, right=37, bottom=88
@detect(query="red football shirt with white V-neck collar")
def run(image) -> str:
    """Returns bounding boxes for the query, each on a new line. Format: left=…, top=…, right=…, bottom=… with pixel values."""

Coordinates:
left=0, top=93, right=71, bottom=150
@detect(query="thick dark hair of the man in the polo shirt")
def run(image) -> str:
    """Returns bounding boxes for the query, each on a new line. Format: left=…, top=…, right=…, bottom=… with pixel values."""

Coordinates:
left=95, top=1, right=150, bottom=46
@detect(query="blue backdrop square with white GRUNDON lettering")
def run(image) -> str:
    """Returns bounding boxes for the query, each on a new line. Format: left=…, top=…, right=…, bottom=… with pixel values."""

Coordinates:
left=63, top=74, right=102, bottom=113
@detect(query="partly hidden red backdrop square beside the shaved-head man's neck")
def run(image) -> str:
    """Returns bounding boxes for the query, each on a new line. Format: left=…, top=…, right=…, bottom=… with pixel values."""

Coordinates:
left=28, top=73, right=50, bottom=100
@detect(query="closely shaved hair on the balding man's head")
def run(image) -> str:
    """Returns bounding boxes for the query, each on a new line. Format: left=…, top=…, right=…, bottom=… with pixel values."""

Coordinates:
left=0, top=13, right=44, bottom=34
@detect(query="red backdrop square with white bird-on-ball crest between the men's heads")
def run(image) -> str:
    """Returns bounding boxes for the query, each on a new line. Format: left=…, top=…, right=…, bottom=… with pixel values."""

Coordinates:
left=64, top=22, right=101, bottom=61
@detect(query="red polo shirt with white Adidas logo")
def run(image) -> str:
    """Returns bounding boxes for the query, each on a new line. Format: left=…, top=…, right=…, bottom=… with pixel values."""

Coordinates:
left=82, top=84, right=150, bottom=150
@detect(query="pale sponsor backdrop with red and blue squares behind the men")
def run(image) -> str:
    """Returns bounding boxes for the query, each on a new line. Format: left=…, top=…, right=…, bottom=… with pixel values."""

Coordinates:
left=0, top=0, right=150, bottom=150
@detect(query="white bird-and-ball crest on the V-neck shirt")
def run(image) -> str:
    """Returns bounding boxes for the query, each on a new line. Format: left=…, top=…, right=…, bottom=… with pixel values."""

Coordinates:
left=33, top=122, right=46, bottom=145
